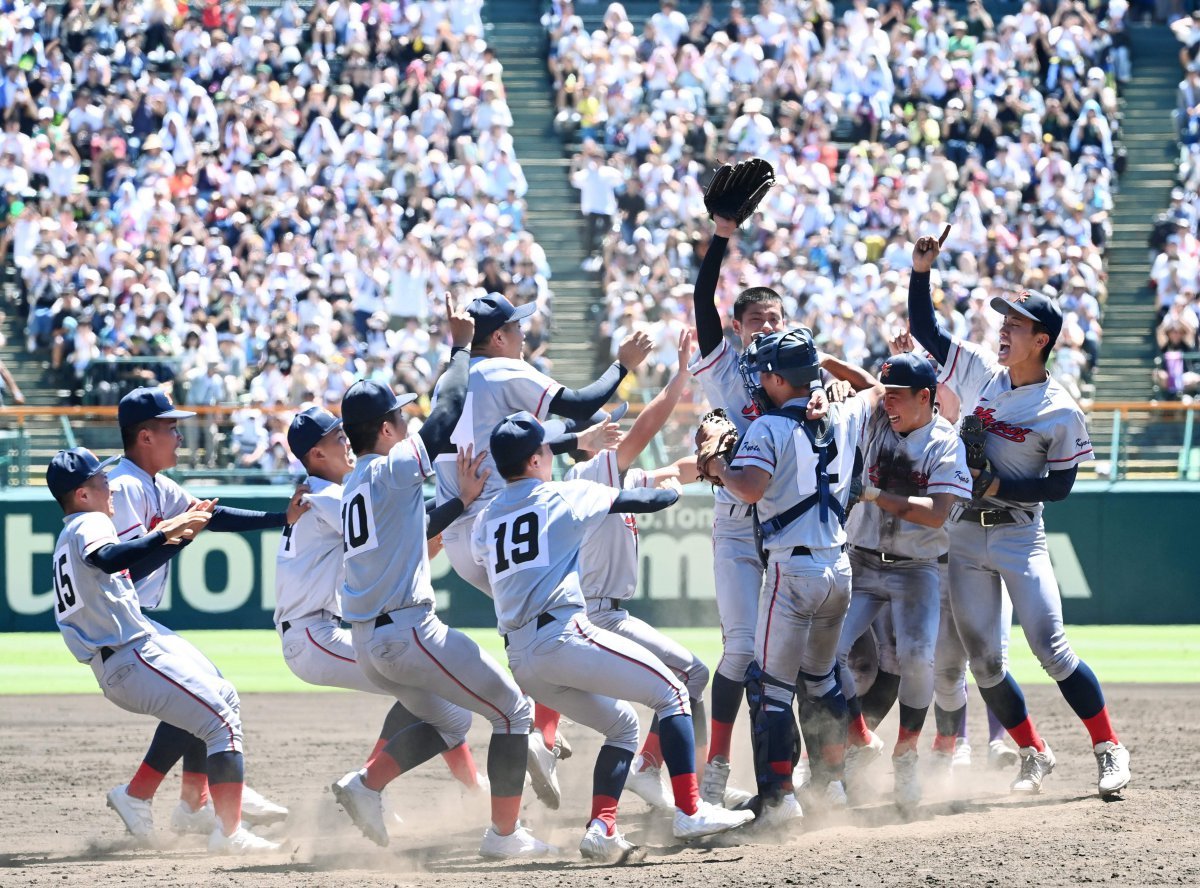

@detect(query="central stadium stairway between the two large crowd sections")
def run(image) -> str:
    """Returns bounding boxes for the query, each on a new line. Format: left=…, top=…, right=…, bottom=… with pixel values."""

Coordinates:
left=484, top=0, right=604, bottom=386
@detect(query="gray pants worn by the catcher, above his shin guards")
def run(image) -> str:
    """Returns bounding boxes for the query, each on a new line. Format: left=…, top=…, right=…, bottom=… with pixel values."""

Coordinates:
left=755, top=550, right=851, bottom=685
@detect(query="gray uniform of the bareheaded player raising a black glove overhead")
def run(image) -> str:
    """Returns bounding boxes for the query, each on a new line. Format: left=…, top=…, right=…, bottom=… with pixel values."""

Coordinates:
left=690, top=340, right=763, bottom=684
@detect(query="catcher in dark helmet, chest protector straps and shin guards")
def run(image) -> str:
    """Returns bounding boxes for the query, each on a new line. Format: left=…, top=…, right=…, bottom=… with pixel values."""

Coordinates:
left=696, top=328, right=877, bottom=826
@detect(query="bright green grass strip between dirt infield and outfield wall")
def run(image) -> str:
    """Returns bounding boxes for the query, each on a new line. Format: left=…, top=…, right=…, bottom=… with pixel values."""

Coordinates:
left=0, top=626, right=1200, bottom=694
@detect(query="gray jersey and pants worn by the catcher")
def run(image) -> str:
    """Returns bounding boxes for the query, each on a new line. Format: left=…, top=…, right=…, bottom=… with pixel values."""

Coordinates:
left=732, top=397, right=870, bottom=706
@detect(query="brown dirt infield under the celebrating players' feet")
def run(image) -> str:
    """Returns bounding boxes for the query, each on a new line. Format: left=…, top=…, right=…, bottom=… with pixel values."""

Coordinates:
left=0, top=685, right=1200, bottom=888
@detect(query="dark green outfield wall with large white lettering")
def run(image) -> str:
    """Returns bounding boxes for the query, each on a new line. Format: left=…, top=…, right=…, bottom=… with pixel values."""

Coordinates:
left=0, top=481, right=1200, bottom=632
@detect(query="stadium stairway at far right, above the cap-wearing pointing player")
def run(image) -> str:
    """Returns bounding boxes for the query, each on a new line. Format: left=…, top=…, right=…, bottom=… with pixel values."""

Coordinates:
left=1090, top=25, right=1182, bottom=476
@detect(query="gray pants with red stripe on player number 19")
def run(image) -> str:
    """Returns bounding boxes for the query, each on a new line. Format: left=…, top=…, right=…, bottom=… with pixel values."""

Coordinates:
left=508, top=611, right=691, bottom=752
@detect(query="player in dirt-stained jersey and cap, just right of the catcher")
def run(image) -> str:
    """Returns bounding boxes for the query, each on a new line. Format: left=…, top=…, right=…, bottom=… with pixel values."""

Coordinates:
left=826, top=353, right=971, bottom=809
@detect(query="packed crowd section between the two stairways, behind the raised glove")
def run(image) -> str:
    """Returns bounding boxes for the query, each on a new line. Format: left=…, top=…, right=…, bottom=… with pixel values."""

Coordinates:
left=544, top=0, right=1130, bottom=398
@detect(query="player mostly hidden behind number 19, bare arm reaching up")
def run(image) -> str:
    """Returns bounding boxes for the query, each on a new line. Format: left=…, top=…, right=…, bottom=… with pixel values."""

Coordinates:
left=566, top=329, right=708, bottom=809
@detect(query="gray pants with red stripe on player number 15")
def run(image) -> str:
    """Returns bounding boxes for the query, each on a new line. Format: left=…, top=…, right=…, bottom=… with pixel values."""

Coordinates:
left=91, top=635, right=241, bottom=755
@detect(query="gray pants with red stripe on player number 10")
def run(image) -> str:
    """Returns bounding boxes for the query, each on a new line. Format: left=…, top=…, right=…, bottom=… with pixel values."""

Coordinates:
left=350, top=607, right=533, bottom=748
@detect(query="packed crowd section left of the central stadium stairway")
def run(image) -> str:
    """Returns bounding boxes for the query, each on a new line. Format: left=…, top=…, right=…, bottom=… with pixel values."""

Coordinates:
left=0, top=0, right=551, bottom=469
